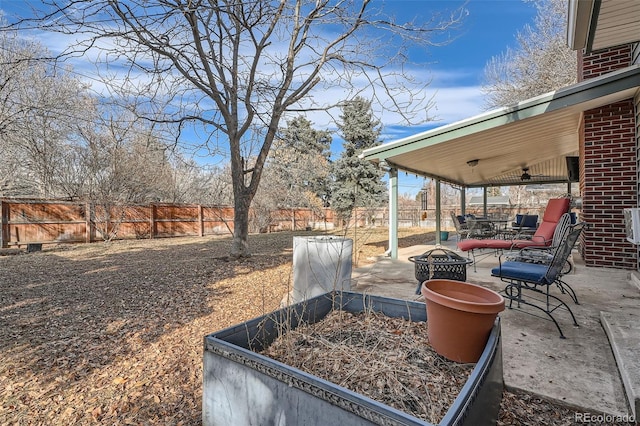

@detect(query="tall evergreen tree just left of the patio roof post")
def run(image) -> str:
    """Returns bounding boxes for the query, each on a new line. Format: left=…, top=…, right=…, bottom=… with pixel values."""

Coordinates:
left=331, top=97, right=387, bottom=218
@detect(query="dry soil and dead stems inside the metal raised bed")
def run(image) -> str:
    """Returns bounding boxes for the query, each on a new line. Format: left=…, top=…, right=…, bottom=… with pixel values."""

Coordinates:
left=263, top=311, right=475, bottom=424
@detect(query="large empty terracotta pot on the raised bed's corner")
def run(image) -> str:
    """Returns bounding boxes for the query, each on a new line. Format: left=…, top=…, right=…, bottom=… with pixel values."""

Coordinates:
left=421, top=280, right=504, bottom=363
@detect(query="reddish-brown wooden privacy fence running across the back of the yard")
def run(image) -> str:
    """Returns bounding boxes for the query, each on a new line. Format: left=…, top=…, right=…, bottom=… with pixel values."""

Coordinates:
left=0, top=199, right=544, bottom=248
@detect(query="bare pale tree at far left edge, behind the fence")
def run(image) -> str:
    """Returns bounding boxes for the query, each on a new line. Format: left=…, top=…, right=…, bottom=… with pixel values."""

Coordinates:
left=0, top=26, right=93, bottom=197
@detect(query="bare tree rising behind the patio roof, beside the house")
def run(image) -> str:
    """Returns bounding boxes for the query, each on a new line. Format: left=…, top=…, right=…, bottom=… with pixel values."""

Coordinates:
left=483, top=0, right=577, bottom=109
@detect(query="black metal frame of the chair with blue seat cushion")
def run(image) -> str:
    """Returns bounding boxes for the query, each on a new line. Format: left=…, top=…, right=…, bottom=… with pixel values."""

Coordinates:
left=493, top=223, right=585, bottom=339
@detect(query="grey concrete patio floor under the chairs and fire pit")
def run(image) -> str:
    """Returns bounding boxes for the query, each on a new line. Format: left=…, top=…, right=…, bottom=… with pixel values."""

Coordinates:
left=352, top=238, right=640, bottom=419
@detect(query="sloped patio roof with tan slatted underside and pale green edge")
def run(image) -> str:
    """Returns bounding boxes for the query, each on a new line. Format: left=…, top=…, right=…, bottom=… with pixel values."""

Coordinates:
left=363, top=65, right=640, bottom=187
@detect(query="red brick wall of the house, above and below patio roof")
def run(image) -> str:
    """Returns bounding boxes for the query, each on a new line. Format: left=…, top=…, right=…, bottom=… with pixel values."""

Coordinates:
left=578, top=45, right=639, bottom=270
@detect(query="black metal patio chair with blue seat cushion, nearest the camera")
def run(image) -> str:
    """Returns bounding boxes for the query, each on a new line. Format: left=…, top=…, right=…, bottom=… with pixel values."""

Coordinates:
left=491, top=223, right=584, bottom=339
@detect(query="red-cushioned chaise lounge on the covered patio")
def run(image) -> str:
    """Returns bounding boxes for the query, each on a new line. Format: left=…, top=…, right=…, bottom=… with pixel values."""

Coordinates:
left=457, top=198, right=570, bottom=268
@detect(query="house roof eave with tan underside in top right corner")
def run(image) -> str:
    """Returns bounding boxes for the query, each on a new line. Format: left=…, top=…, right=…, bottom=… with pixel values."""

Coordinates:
left=567, top=0, right=640, bottom=54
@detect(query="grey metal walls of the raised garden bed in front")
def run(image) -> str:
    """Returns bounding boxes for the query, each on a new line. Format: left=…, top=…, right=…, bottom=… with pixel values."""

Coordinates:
left=202, top=292, right=503, bottom=426
